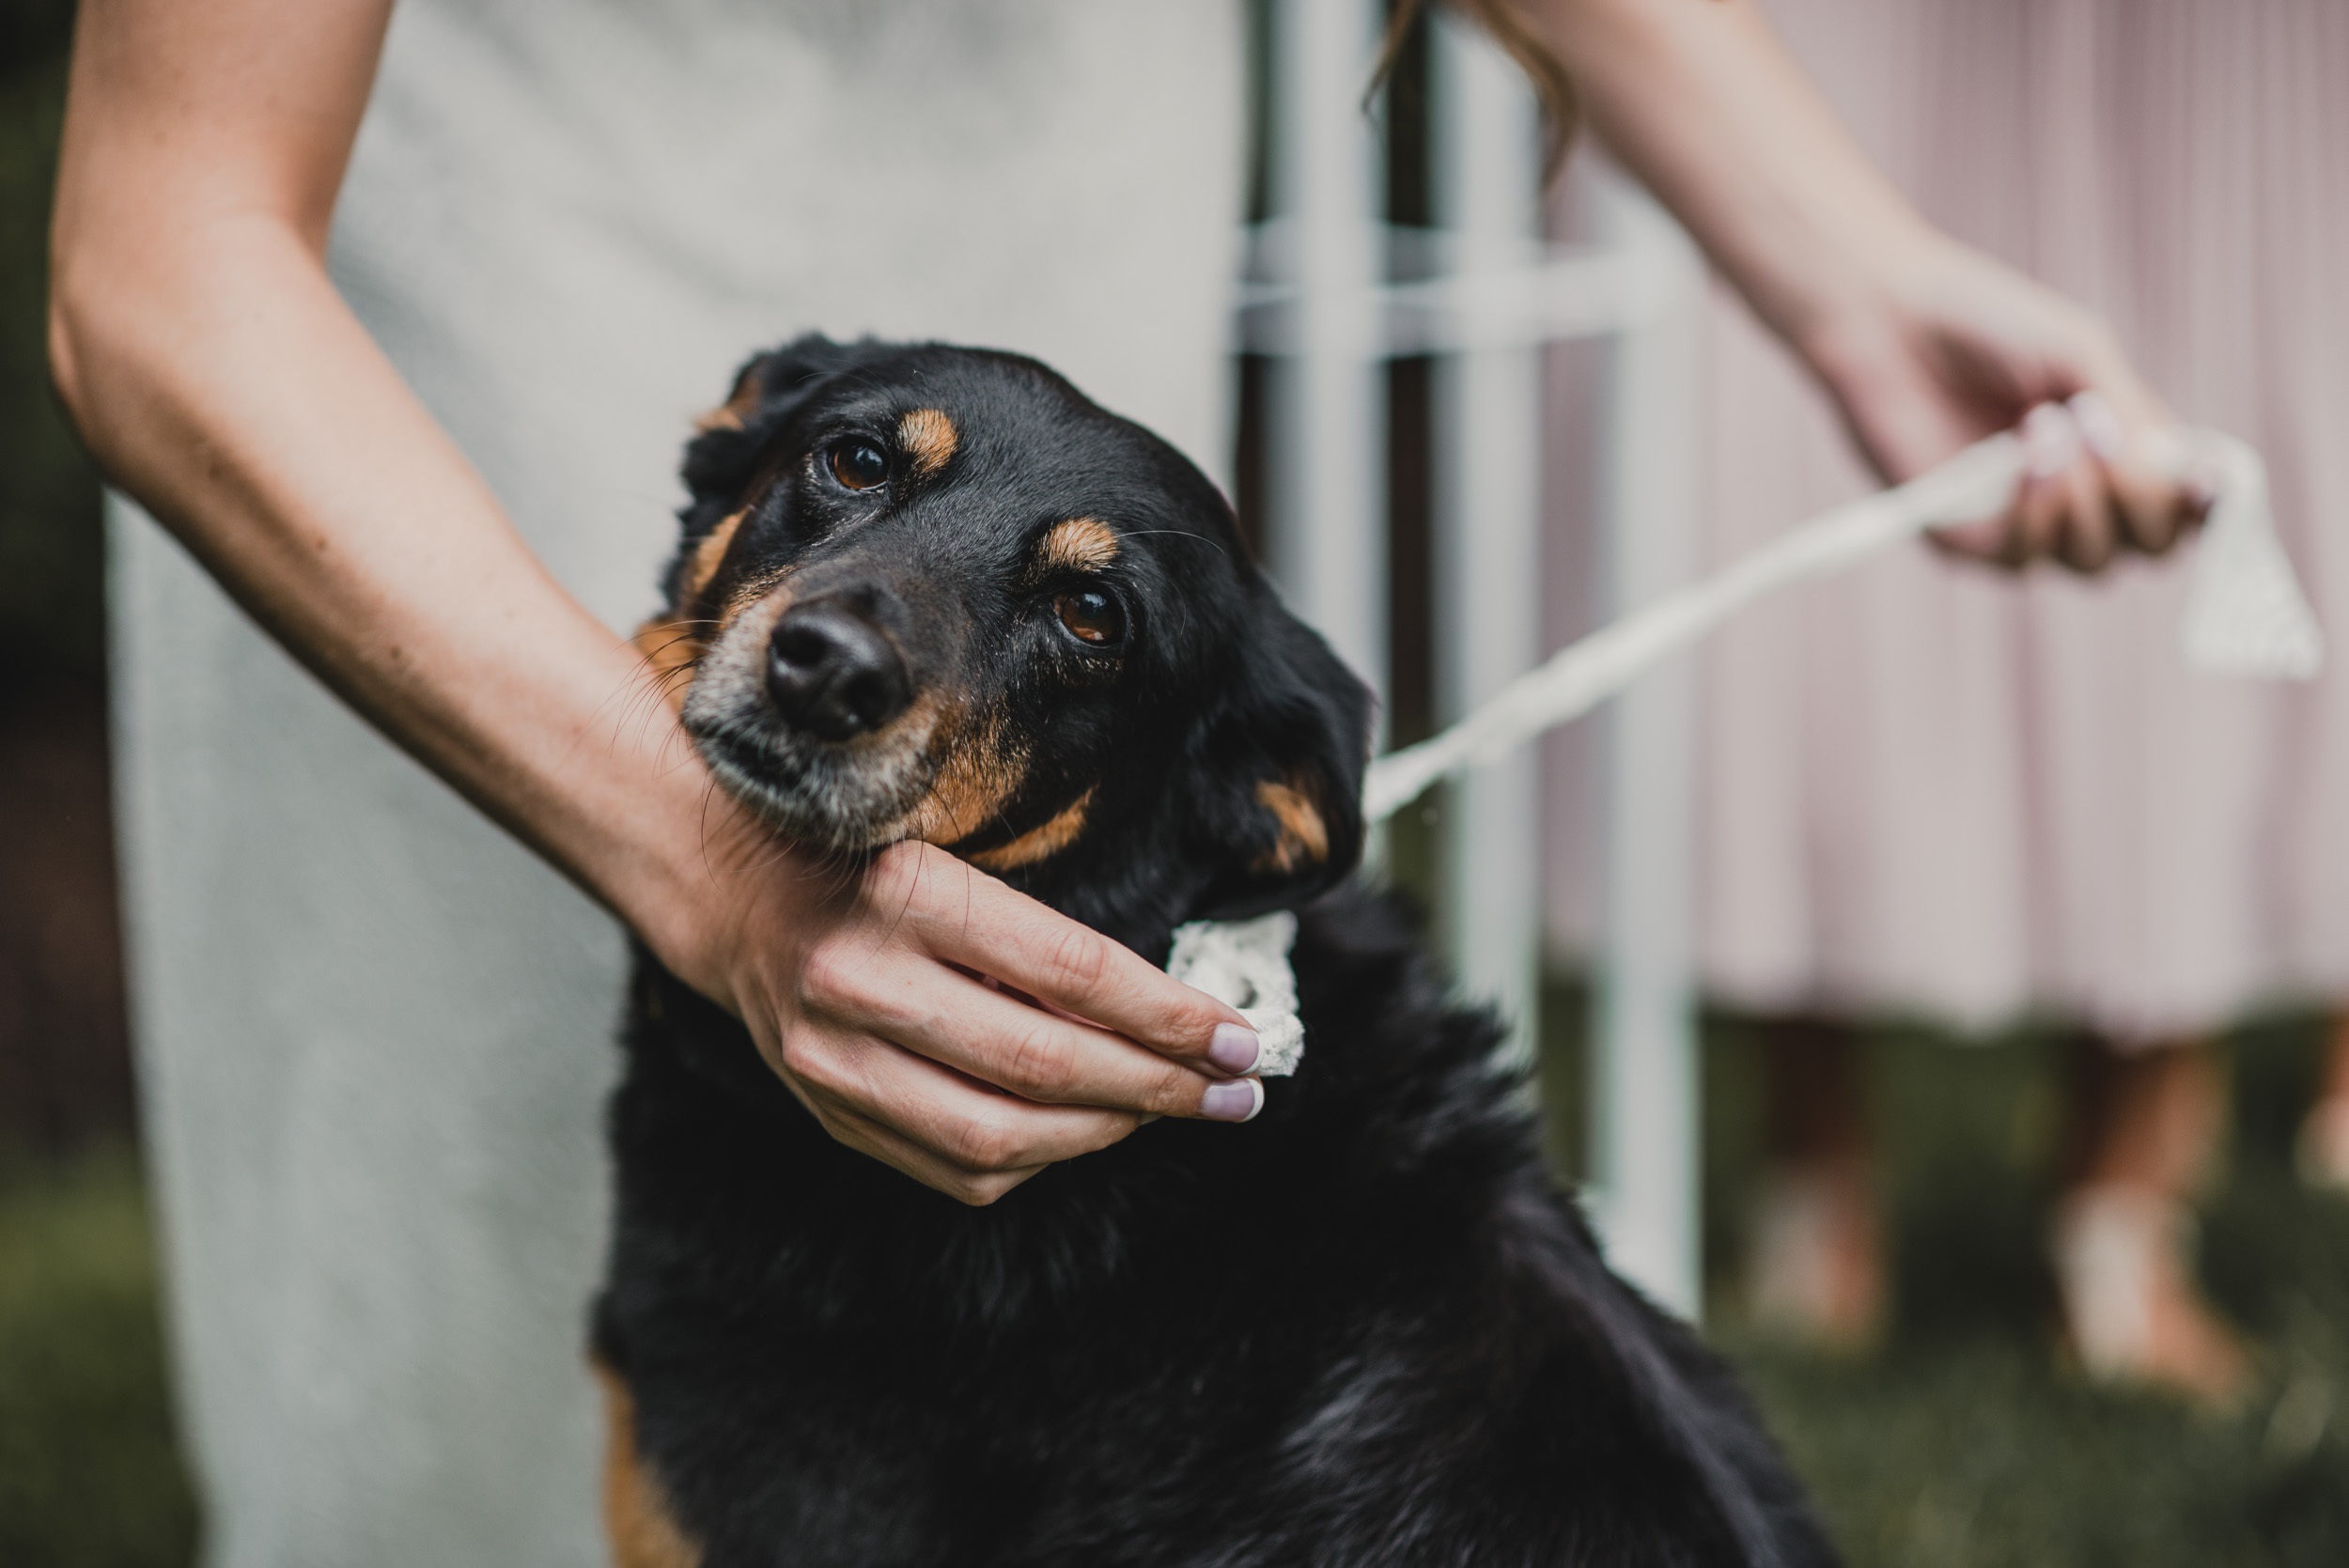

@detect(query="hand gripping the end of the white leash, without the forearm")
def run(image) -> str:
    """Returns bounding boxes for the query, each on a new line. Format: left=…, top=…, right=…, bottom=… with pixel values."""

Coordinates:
left=1795, top=237, right=2208, bottom=573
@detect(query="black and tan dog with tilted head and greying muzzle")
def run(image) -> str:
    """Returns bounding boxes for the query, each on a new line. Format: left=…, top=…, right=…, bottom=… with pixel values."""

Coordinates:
left=595, top=338, right=1832, bottom=1568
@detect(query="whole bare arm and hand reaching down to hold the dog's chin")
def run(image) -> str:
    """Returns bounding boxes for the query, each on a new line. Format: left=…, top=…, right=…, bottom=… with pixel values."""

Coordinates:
left=50, top=0, right=1268, bottom=1200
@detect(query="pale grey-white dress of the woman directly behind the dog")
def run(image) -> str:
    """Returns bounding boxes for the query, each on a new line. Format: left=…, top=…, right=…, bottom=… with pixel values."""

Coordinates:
left=113, top=0, right=1240, bottom=1568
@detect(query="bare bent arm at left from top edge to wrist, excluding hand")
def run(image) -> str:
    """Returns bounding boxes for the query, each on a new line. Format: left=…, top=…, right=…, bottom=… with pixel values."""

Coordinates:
left=50, top=0, right=723, bottom=957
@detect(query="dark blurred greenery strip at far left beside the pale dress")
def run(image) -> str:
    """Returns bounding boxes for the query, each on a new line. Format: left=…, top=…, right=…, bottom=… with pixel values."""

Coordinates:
left=0, top=0, right=195, bottom=1568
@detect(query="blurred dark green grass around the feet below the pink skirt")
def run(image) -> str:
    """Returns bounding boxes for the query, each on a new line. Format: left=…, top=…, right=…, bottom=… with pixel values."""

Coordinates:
left=1708, top=1023, right=2349, bottom=1568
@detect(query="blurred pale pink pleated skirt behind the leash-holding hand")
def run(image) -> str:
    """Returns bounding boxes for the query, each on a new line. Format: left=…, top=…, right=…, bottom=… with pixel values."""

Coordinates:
left=1672, top=0, right=2349, bottom=1042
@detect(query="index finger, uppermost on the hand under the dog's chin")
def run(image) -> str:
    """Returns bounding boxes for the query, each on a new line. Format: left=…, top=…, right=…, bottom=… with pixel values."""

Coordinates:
left=869, top=843, right=1257, bottom=1079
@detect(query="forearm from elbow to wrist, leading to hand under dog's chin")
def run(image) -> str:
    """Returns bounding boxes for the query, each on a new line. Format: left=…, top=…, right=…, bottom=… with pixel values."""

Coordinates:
left=56, top=218, right=723, bottom=934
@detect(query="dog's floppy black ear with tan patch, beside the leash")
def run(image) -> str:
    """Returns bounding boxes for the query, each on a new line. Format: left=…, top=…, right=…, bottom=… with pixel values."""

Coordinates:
left=1184, top=592, right=1370, bottom=920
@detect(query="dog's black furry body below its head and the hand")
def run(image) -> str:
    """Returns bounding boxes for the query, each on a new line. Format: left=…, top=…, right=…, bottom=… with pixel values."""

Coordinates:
left=597, top=894, right=1830, bottom=1568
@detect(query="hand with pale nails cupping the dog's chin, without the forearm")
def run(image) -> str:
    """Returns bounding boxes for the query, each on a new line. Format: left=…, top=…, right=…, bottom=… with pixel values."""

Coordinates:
left=639, top=796, right=1262, bottom=1204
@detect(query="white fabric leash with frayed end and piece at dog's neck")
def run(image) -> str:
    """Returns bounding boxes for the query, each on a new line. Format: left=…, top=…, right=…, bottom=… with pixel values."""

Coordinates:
left=1168, top=429, right=2326, bottom=1075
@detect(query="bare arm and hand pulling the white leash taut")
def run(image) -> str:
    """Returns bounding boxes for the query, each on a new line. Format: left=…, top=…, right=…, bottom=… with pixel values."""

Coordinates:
left=1513, top=0, right=2197, bottom=568
